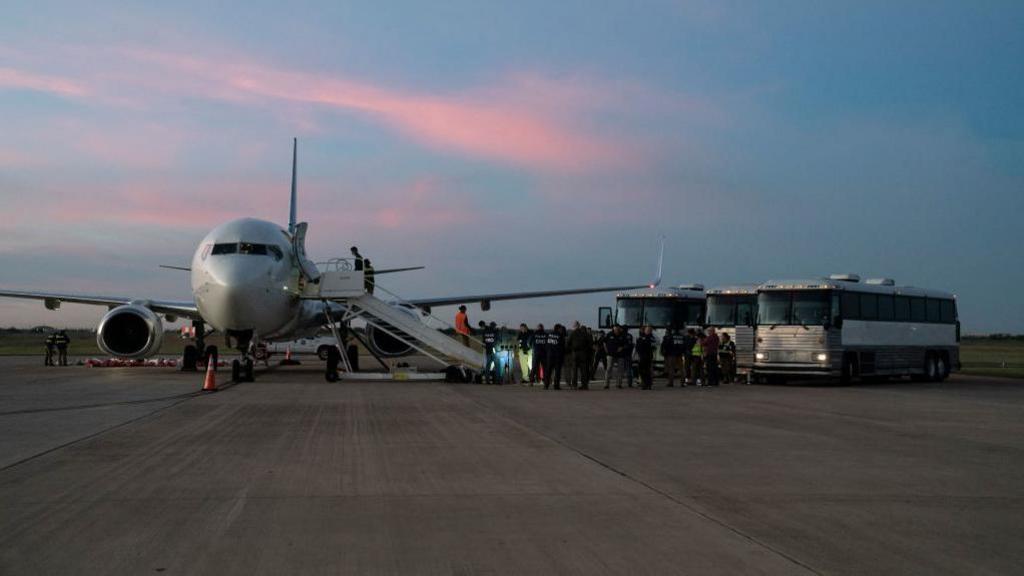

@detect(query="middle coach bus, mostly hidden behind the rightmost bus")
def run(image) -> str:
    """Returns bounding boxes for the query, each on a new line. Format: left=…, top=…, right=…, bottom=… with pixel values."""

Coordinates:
left=706, top=285, right=758, bottom=374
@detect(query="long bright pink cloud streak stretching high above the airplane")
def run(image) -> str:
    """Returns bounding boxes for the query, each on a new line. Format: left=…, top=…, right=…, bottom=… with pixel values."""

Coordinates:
left=114, top=50, right=639, bottom=170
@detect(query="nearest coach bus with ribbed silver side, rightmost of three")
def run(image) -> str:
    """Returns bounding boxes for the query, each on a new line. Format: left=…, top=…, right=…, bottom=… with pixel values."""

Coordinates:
left=754, top=275, right=959, bottom=382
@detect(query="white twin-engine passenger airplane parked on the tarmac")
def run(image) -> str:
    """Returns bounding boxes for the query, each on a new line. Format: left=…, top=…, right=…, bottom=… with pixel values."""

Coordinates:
left=0, top=138, right=665, bottom=380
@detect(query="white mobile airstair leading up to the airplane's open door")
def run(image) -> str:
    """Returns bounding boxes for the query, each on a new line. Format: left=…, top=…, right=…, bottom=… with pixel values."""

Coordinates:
left=303, top=258, right=483, bottom=370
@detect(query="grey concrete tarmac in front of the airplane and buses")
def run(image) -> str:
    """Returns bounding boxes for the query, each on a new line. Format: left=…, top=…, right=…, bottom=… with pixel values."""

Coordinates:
left=0, top=359, right=1024, bottom=574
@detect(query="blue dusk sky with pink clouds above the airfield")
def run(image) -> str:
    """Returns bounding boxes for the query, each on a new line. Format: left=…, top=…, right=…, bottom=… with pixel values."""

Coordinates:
left=0, top=0, right=1024, bottom=333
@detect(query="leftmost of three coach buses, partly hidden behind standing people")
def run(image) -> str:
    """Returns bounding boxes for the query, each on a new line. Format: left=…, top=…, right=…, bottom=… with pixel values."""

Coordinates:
left=598, top=284, right=707, bottom=369
